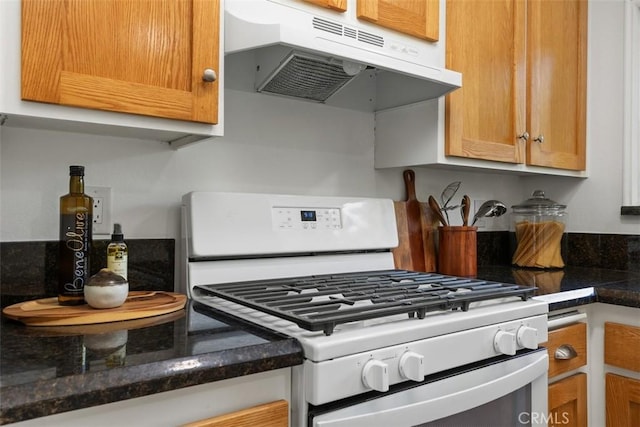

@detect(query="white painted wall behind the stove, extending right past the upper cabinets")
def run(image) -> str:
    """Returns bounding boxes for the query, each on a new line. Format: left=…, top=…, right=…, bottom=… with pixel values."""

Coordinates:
left=0, top=0, right=640, bottom=246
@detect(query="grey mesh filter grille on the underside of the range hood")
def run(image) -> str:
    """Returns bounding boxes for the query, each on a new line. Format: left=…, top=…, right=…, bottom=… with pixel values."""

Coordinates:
left=258, top=52, right=357, bottom=102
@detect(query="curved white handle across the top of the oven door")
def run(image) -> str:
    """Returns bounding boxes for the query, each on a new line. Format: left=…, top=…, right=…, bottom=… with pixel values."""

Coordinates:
left=312, top=349, right=549, bottom=427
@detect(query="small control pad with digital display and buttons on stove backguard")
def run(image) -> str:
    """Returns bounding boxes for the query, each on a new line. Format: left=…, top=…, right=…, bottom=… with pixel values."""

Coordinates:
left=271, top=206, right=342, bottom=231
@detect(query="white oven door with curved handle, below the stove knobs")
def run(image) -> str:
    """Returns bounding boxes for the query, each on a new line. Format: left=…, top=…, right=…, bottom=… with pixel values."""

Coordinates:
left=309, top=348, right=549, bottom=427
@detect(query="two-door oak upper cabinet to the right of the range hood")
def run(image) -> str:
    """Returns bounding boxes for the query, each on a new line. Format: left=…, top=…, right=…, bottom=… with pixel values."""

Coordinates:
left=445, top=0, right=587, bottom=171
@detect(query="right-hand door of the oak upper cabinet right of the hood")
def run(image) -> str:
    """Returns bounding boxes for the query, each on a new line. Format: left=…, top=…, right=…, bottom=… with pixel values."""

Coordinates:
left=527, top=0, right=587, bottom=170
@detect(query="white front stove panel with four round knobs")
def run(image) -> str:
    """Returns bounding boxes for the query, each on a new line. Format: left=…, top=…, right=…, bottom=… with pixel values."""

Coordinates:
left=304, top=315, right=548, bottom=405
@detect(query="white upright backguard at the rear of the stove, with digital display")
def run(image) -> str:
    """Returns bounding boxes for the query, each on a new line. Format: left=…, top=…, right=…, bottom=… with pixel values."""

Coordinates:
left=182, top=191, right=398, bottom=258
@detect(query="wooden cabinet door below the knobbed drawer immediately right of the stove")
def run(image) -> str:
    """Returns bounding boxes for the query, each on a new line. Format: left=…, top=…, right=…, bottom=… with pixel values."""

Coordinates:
left=549, top=373, right=587, bottom=427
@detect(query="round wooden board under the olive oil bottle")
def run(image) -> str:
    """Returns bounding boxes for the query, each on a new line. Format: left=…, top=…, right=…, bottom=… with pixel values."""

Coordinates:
left=2, top=291, right=187, bottom=326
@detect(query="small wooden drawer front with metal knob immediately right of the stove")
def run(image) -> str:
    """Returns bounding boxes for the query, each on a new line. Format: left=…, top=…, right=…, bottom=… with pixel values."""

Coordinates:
left=542, top=323, right=587, bottom=378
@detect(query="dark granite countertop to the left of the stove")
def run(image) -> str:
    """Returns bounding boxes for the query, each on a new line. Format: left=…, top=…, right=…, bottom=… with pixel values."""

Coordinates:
left=0, top=301, right=302, bottom=424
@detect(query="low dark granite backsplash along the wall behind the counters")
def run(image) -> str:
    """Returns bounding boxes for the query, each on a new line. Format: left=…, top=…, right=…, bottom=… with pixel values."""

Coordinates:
left=0, top=231, right=640, bottom=307
